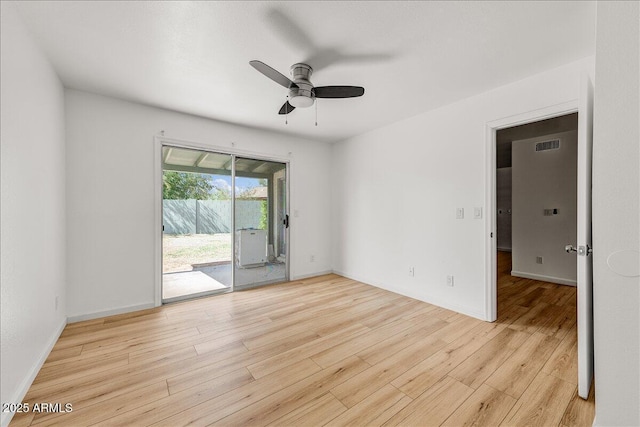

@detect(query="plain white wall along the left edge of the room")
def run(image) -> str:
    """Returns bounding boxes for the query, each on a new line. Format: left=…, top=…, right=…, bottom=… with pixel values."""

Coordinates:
left=0, top=2, right=66, bottom=425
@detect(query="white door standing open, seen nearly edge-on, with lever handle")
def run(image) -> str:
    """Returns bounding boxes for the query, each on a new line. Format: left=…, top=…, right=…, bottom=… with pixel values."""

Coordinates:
left=576, top=75, right=593, bottom=399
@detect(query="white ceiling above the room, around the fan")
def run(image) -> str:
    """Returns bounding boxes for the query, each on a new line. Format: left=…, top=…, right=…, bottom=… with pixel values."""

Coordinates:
left=16, top=1, right=596, bottom=142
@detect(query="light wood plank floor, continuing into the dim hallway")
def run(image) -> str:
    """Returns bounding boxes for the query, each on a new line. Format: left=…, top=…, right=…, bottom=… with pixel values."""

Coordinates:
left=12, top=254, right=594, bottom=426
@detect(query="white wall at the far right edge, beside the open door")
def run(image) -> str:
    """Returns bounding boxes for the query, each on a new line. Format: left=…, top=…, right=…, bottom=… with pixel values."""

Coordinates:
left=593, top=1, right=640, bottom=426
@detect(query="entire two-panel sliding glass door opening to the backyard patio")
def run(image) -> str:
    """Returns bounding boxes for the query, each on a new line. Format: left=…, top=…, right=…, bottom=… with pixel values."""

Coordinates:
left=160, top=142, right=289, bottom=303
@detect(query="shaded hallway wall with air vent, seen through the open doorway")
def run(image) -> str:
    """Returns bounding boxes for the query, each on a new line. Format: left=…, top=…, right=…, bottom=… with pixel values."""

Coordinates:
left=511, top=131, right=578, bottom=285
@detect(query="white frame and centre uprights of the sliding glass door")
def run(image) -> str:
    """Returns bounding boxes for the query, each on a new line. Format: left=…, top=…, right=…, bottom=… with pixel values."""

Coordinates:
left=153, top=135, right=292, bottom=307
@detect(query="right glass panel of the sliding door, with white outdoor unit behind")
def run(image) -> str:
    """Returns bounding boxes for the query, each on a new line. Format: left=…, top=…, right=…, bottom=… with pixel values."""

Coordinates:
left=234, top=157, right=288, bottom=288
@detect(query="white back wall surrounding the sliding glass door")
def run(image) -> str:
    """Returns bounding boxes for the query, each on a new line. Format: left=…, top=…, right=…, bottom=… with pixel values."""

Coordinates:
left=66, top=90, right=331, bottom=320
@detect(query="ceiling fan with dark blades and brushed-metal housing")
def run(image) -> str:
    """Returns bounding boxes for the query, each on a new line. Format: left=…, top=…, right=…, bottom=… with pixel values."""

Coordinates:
left=249, top=61, right=364, bottom=114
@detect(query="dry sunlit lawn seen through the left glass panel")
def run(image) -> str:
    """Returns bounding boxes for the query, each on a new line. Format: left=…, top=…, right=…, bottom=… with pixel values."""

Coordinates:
left=162, top=233, right=231, bottom=273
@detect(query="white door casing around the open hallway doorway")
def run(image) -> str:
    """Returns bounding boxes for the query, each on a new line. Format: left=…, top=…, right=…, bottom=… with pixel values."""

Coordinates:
left=484, top=99, right=579, bottom=322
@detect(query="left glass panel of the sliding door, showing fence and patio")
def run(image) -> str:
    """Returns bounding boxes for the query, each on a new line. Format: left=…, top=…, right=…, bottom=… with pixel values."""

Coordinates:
left=162, top=146, right=233, bottom=302
